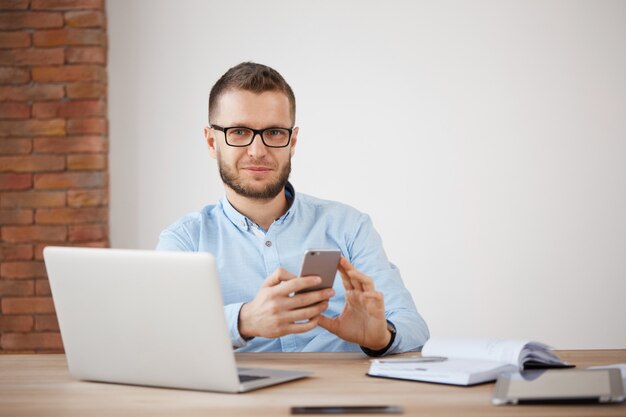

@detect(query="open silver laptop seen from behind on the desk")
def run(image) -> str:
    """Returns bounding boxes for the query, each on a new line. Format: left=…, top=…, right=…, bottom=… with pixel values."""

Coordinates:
left=44, top=247, right=311, bottom=393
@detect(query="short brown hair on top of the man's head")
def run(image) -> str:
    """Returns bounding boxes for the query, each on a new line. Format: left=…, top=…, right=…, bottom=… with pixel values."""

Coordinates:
left=209, top=62, right=296, bottom=124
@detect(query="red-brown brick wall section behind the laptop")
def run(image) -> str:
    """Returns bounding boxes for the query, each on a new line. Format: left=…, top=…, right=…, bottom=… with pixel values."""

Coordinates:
left=0, top=0, right=108, bottom=352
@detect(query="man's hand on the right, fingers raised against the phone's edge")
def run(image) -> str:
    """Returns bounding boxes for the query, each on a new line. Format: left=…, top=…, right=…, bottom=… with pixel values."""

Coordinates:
left=318, top=257, right=391, bottom=350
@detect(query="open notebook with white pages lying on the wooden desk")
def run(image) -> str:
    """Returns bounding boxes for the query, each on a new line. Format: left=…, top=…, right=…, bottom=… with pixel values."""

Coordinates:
left=368, top=338, right=572, bottom=385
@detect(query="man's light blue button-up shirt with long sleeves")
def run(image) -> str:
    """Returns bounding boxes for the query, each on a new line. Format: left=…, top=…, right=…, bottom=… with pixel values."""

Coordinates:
left=157, top=184, right=429, bottom=354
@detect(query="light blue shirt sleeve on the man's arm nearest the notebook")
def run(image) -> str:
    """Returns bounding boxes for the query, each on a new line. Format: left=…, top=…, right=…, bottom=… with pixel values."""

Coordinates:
left=348, top=214, right=430, bottom=355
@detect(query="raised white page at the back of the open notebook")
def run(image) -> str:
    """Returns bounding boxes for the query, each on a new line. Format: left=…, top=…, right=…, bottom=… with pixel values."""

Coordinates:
left=422, top=337, right=528, bottom=367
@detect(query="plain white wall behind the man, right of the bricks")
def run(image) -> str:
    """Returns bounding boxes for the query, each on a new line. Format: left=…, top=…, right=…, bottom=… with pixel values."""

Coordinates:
left=107, top=0, right=626, bottom=349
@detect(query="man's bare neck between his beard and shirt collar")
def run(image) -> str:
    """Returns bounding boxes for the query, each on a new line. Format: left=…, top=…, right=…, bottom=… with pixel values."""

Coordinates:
left=224, top=186, right=289, bottom=230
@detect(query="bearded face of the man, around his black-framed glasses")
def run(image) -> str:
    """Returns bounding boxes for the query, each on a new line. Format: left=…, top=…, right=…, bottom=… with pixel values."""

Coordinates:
left=204, top=90, right=298, bottom=200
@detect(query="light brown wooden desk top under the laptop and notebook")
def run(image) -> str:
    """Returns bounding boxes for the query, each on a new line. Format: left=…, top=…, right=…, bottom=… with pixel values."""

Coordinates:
left=0, top=350, right=626, bottom=417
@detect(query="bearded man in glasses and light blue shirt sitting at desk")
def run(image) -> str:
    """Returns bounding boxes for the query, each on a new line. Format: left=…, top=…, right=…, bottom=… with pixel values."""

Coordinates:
left=157, top=62, right=429, bottom=356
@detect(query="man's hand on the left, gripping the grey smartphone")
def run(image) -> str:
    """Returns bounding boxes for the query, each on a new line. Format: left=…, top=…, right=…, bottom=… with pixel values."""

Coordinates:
left=239, top=268, right=335, bottom=339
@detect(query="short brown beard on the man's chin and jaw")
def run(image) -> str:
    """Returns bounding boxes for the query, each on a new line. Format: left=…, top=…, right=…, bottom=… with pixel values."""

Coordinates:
left=217, top=153, right=291, bottom=200
